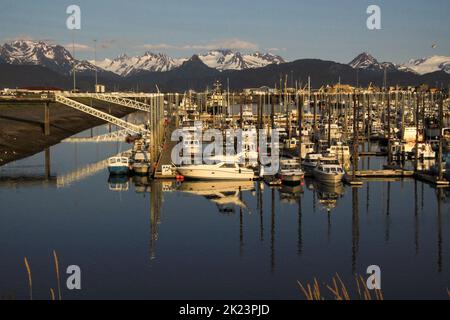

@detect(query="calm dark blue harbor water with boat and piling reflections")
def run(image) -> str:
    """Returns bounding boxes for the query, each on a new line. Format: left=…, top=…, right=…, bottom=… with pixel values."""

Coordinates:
left=0, top=122, right=450, bottom=299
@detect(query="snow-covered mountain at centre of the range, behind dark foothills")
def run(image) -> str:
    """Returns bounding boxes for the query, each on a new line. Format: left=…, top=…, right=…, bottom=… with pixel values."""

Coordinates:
left=199, top=50, right=285, bottom=71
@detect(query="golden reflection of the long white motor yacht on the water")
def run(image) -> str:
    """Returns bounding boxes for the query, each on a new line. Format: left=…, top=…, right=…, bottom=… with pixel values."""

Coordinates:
left=178, top=181, right=255, bottom=212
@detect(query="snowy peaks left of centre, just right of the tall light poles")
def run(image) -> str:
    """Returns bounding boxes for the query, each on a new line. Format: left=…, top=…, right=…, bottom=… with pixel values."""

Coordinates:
left=90, top=52, right=187, bottom=76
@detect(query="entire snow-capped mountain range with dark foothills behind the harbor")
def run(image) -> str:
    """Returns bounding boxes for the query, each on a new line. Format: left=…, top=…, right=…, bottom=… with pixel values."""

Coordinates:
left=0, top=40, right=450, bottom=91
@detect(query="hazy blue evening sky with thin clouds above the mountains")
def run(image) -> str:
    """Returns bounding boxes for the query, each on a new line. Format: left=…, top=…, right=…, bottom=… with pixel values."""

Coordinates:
left=0, top=0, right=450, bottom=63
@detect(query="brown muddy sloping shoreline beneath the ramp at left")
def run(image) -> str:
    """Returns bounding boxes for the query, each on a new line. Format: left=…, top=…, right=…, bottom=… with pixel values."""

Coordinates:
left=0, top=99, right=135, bottom=166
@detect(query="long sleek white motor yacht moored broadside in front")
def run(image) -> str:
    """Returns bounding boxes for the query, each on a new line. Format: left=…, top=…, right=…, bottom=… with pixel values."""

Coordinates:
left=177, top=162, right=255, bottom=180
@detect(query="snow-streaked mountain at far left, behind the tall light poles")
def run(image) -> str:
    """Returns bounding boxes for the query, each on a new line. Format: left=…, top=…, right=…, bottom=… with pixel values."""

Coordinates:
left=0, top=40, right=100, bottom=74
